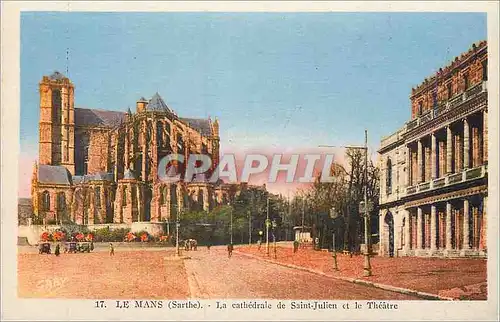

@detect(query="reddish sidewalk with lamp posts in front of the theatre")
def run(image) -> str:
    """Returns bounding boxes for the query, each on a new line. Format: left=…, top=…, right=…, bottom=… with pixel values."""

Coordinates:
left=235, top=245, right=487, bottom=300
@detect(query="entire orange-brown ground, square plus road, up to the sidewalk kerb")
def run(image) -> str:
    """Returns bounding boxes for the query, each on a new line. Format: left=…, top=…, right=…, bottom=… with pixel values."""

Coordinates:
left=18, top=247, right=417, bottom=300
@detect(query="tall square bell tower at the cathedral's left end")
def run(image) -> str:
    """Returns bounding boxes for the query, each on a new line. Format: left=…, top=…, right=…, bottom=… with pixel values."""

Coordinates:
left=39, top=71, right=75, bottom=175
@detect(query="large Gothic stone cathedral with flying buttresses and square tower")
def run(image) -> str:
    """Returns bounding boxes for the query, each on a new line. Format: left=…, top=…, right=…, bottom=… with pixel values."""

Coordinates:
left=31, top=72, right=244, bottom=231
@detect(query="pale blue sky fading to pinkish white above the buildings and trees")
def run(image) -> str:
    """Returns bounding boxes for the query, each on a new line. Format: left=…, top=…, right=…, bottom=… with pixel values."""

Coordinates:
left=19, top=12, right=486, bottom=197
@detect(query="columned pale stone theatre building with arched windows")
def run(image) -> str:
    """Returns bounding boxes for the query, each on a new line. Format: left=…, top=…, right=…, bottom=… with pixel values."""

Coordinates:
left=378, top=41, right=488, bottom=257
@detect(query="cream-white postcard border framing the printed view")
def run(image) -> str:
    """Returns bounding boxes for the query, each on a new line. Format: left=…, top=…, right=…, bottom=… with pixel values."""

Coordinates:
left=1, top=1, right=499, bottom=320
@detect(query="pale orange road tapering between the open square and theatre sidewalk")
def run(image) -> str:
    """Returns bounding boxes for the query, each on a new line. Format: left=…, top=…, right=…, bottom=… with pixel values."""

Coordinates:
left=180, top=247, right=417, bottom=300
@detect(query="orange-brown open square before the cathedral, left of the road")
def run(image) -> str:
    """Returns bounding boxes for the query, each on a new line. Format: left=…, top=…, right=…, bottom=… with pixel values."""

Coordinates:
left=18, top=250, right=189, bottom=299
